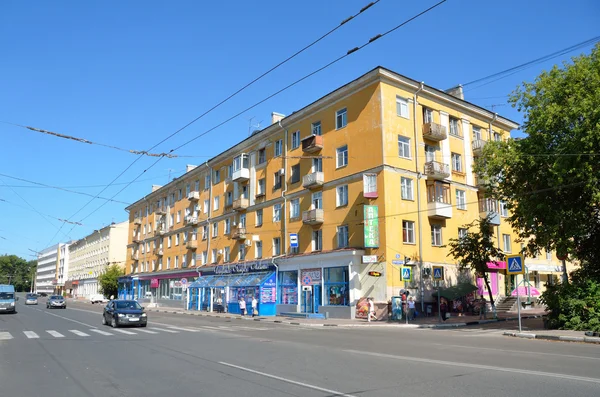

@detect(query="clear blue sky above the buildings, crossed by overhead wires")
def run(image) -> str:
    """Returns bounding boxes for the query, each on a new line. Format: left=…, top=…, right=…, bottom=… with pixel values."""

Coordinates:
left=0, top=0, right=600, bottom=259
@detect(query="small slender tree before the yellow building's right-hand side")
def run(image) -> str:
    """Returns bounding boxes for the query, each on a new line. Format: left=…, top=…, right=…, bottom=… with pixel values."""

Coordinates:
left=448, top=215, right=504, bottom=317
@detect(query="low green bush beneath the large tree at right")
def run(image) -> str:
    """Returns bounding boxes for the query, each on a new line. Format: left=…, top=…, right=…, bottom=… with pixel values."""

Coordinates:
left=540, top=277, right=600, bottom=332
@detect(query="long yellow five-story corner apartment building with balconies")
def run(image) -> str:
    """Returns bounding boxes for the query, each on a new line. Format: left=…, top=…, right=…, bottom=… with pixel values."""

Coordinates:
left=122, top=67, right=568, bottom=318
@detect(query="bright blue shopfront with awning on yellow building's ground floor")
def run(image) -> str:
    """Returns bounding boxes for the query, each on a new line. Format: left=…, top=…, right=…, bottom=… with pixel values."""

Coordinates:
left=188, top=261, right=277, bottom=316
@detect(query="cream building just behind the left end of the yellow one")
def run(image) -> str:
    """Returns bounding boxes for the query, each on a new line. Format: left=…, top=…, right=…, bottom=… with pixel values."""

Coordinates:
left=65, top=222, right=129, bottom=298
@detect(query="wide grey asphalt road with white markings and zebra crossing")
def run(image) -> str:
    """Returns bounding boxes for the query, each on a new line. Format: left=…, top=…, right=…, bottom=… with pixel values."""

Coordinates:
left=0, top=299, right=600, bottom=397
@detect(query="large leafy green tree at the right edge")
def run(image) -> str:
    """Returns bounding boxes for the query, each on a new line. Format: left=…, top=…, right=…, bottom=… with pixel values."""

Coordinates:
left=475, top=45, right=600, bottom=281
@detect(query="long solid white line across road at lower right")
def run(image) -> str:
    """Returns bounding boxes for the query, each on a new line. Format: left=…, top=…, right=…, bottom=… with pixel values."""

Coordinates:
left=343, top=350, right=600, bottom=384
